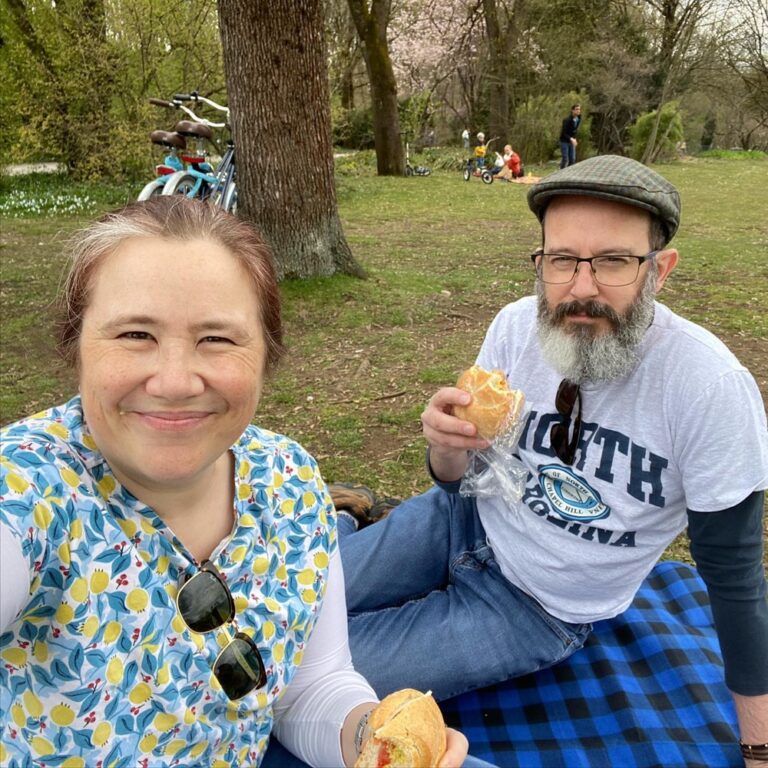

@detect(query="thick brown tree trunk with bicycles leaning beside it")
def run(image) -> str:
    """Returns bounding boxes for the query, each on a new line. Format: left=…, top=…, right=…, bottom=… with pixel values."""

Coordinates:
left=218, top=0, right=365, bottom=278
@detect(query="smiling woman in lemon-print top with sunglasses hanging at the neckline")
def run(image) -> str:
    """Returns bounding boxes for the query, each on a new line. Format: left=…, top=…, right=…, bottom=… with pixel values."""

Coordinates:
left=0, top=197, right=466, bottom=766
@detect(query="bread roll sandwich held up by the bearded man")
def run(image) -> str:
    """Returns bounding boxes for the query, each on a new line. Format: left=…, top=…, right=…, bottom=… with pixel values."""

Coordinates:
left=453, top=365, right=525, bottom=440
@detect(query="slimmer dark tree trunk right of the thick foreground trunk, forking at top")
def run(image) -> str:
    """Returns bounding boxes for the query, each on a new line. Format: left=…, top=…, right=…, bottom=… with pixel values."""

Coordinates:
left=349, top=0, right=405, bottom=176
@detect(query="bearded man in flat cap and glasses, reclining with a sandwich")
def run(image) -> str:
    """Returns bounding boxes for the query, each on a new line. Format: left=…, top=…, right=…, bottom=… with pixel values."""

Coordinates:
left=340, top=156, right=768, bottom=762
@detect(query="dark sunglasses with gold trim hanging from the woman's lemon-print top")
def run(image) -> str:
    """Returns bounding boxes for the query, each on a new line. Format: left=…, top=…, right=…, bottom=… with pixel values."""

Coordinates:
left=176, top=560, right=267, bottom=701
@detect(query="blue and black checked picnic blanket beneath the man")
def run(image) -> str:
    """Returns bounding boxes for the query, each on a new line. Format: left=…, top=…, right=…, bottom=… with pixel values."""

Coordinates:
left=440, top=562, right=744, bottom=768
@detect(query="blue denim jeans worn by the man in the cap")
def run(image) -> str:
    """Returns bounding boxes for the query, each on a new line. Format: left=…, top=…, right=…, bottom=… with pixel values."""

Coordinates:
left=339, top=488, right=591, bottom=700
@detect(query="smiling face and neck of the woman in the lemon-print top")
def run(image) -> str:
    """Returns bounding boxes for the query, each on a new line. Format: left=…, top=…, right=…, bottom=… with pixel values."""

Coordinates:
left=78, top=238, right=266, bottom=536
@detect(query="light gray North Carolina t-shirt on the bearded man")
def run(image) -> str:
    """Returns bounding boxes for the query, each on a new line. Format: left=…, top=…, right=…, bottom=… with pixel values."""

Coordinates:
left=477, top=297, right=768, bottom=623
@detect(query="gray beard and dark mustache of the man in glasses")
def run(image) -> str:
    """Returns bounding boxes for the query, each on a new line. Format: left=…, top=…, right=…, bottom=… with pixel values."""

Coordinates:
left=536, top=262, right=657, bottom=384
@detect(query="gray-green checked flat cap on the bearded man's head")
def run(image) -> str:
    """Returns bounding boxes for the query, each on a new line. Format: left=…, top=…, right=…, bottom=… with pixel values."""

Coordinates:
left=528, top=155, right=680, bottom=242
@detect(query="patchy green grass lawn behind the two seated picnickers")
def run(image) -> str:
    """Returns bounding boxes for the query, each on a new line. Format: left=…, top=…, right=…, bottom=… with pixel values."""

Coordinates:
left=0, top=159, right=768, bottom=560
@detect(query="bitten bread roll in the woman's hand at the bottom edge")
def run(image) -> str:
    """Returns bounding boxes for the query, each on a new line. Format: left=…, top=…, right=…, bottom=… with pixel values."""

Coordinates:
left=355, top=688, right=446, bottom=768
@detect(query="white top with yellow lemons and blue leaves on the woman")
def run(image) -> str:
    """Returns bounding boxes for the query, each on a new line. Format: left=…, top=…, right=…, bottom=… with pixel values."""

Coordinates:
left=0, top=398, right=336, bottom=768
